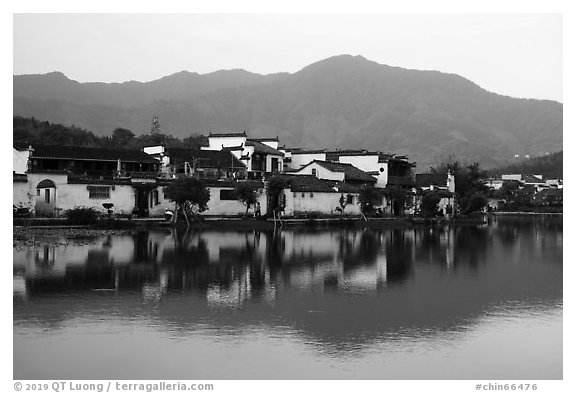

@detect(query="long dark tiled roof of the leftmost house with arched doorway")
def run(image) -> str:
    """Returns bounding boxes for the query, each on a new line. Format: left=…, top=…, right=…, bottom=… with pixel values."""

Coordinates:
left=32, top=145, right=158, bottom=164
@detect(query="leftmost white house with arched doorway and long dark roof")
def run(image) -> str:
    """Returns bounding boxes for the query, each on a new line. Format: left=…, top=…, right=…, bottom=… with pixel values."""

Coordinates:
left=13, top=145, right=166, bottom=217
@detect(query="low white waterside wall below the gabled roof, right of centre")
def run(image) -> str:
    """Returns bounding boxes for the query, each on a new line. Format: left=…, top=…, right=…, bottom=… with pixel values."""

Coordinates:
left=284, top=189, right=360, bottom=216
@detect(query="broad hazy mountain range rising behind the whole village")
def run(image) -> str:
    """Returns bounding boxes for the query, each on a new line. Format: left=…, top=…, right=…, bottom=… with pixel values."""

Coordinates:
left=14, top=55, right=563, bottom=168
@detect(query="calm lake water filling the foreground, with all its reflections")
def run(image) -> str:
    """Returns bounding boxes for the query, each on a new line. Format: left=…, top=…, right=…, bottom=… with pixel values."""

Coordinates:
left=13, top=217, right=562, bottom=380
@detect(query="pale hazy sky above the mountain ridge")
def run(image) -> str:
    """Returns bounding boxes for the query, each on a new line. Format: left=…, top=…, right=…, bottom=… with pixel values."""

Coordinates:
left=13, top=14, right=563, bottom=101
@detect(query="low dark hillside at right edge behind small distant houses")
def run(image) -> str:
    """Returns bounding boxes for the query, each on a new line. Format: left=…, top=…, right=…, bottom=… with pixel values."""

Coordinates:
left=490, top=151, right=564, bottom=179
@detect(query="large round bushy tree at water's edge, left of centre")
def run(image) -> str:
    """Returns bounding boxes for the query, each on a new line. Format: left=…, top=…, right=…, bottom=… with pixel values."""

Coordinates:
left=164, top=178, right=210, bottom=226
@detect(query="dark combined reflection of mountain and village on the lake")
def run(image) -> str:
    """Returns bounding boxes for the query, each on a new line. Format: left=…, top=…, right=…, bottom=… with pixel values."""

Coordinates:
left=14, top=216, right=562, bottom=349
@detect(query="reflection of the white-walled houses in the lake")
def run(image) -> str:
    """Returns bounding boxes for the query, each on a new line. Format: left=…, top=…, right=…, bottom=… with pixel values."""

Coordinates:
left=14, top=230, right=411, bottom=298
